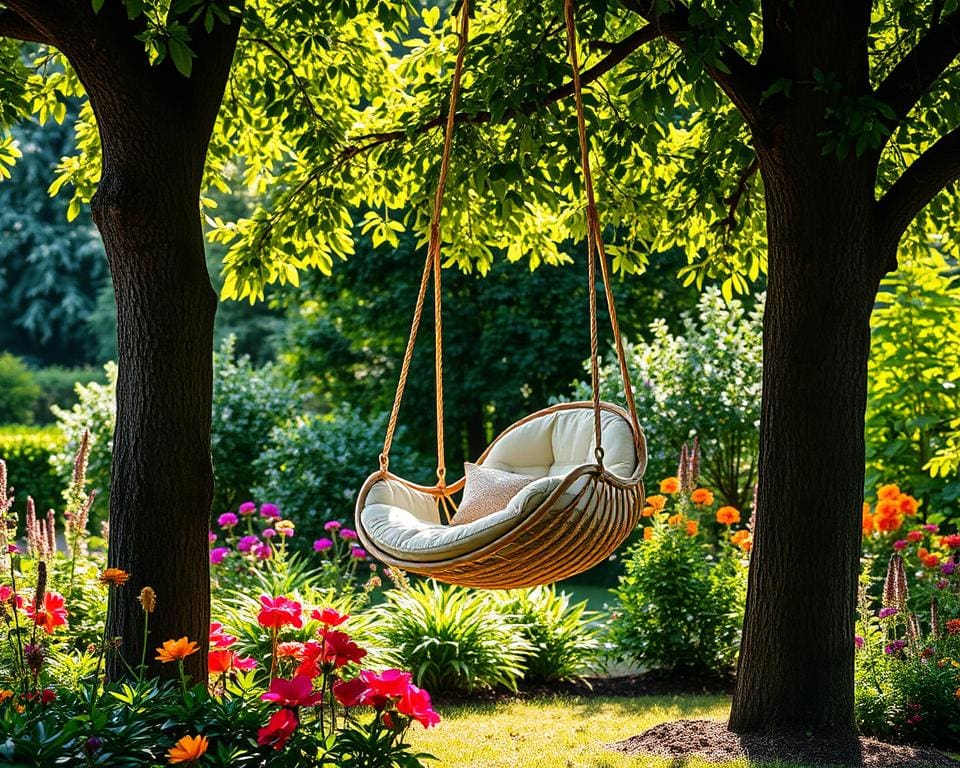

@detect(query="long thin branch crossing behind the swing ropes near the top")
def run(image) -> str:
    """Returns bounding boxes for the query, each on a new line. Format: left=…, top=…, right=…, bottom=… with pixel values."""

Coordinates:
left=343, top=24, right=660, bottom=157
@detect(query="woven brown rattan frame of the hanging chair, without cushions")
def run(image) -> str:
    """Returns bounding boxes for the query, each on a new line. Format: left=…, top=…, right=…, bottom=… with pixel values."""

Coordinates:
left=356, top=402, right=647, bottom=589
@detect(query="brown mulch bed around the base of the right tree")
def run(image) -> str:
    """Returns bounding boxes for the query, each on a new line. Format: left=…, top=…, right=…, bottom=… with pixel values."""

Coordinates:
left=608, top=720, right=960, bottom=768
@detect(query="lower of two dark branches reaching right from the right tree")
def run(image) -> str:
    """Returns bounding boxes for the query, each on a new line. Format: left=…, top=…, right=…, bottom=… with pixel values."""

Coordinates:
left=877, top=128, right=960, bottom=241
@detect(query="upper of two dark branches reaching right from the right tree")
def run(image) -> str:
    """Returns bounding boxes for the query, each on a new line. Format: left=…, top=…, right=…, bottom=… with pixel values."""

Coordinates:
left=875, top=10, right=960, bottom=121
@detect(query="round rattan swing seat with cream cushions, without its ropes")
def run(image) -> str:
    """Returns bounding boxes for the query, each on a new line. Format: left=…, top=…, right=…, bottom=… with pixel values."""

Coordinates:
left=357, top=402, right=646, bottom=589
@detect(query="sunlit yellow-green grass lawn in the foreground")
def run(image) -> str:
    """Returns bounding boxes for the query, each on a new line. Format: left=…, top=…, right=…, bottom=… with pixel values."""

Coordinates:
left=408, top=696, right=832, bottom=768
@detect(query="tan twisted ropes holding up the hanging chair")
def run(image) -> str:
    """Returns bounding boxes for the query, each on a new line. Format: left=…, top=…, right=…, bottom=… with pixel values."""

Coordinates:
left=380, top=0, right=641, bottom=484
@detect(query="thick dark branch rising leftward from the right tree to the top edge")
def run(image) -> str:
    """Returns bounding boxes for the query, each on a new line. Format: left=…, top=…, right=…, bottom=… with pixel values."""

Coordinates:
left=621, top=0, right=764, bottom=125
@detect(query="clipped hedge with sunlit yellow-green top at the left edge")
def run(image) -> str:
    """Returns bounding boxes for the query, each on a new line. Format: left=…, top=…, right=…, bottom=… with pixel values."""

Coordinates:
left=0, top=426, right=66, bottom=512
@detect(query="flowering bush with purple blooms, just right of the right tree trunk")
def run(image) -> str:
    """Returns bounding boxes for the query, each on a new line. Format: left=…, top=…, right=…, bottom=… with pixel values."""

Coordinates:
left=854, top=548, right=960, bottom=750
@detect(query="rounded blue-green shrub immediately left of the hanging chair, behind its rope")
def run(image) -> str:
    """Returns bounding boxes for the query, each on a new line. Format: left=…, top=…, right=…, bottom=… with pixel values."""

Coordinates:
left=248, top=408, right=430, bottom=541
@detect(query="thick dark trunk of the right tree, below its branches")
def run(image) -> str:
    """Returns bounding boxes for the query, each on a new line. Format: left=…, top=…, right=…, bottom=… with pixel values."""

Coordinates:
left=730, top=142, right=880, bottom=735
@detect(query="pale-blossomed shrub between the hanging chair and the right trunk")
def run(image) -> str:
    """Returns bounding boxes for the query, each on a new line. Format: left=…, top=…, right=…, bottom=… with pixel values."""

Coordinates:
left=576, top=288, right=763, bottom=509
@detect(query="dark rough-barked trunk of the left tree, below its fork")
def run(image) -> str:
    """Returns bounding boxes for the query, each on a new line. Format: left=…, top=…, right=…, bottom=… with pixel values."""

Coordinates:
left=94, top=165, right=216, bottom=680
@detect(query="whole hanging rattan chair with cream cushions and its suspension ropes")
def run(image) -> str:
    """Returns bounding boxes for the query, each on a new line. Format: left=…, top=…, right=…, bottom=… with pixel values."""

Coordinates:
left=356, top=0, right=646, bottom=589
